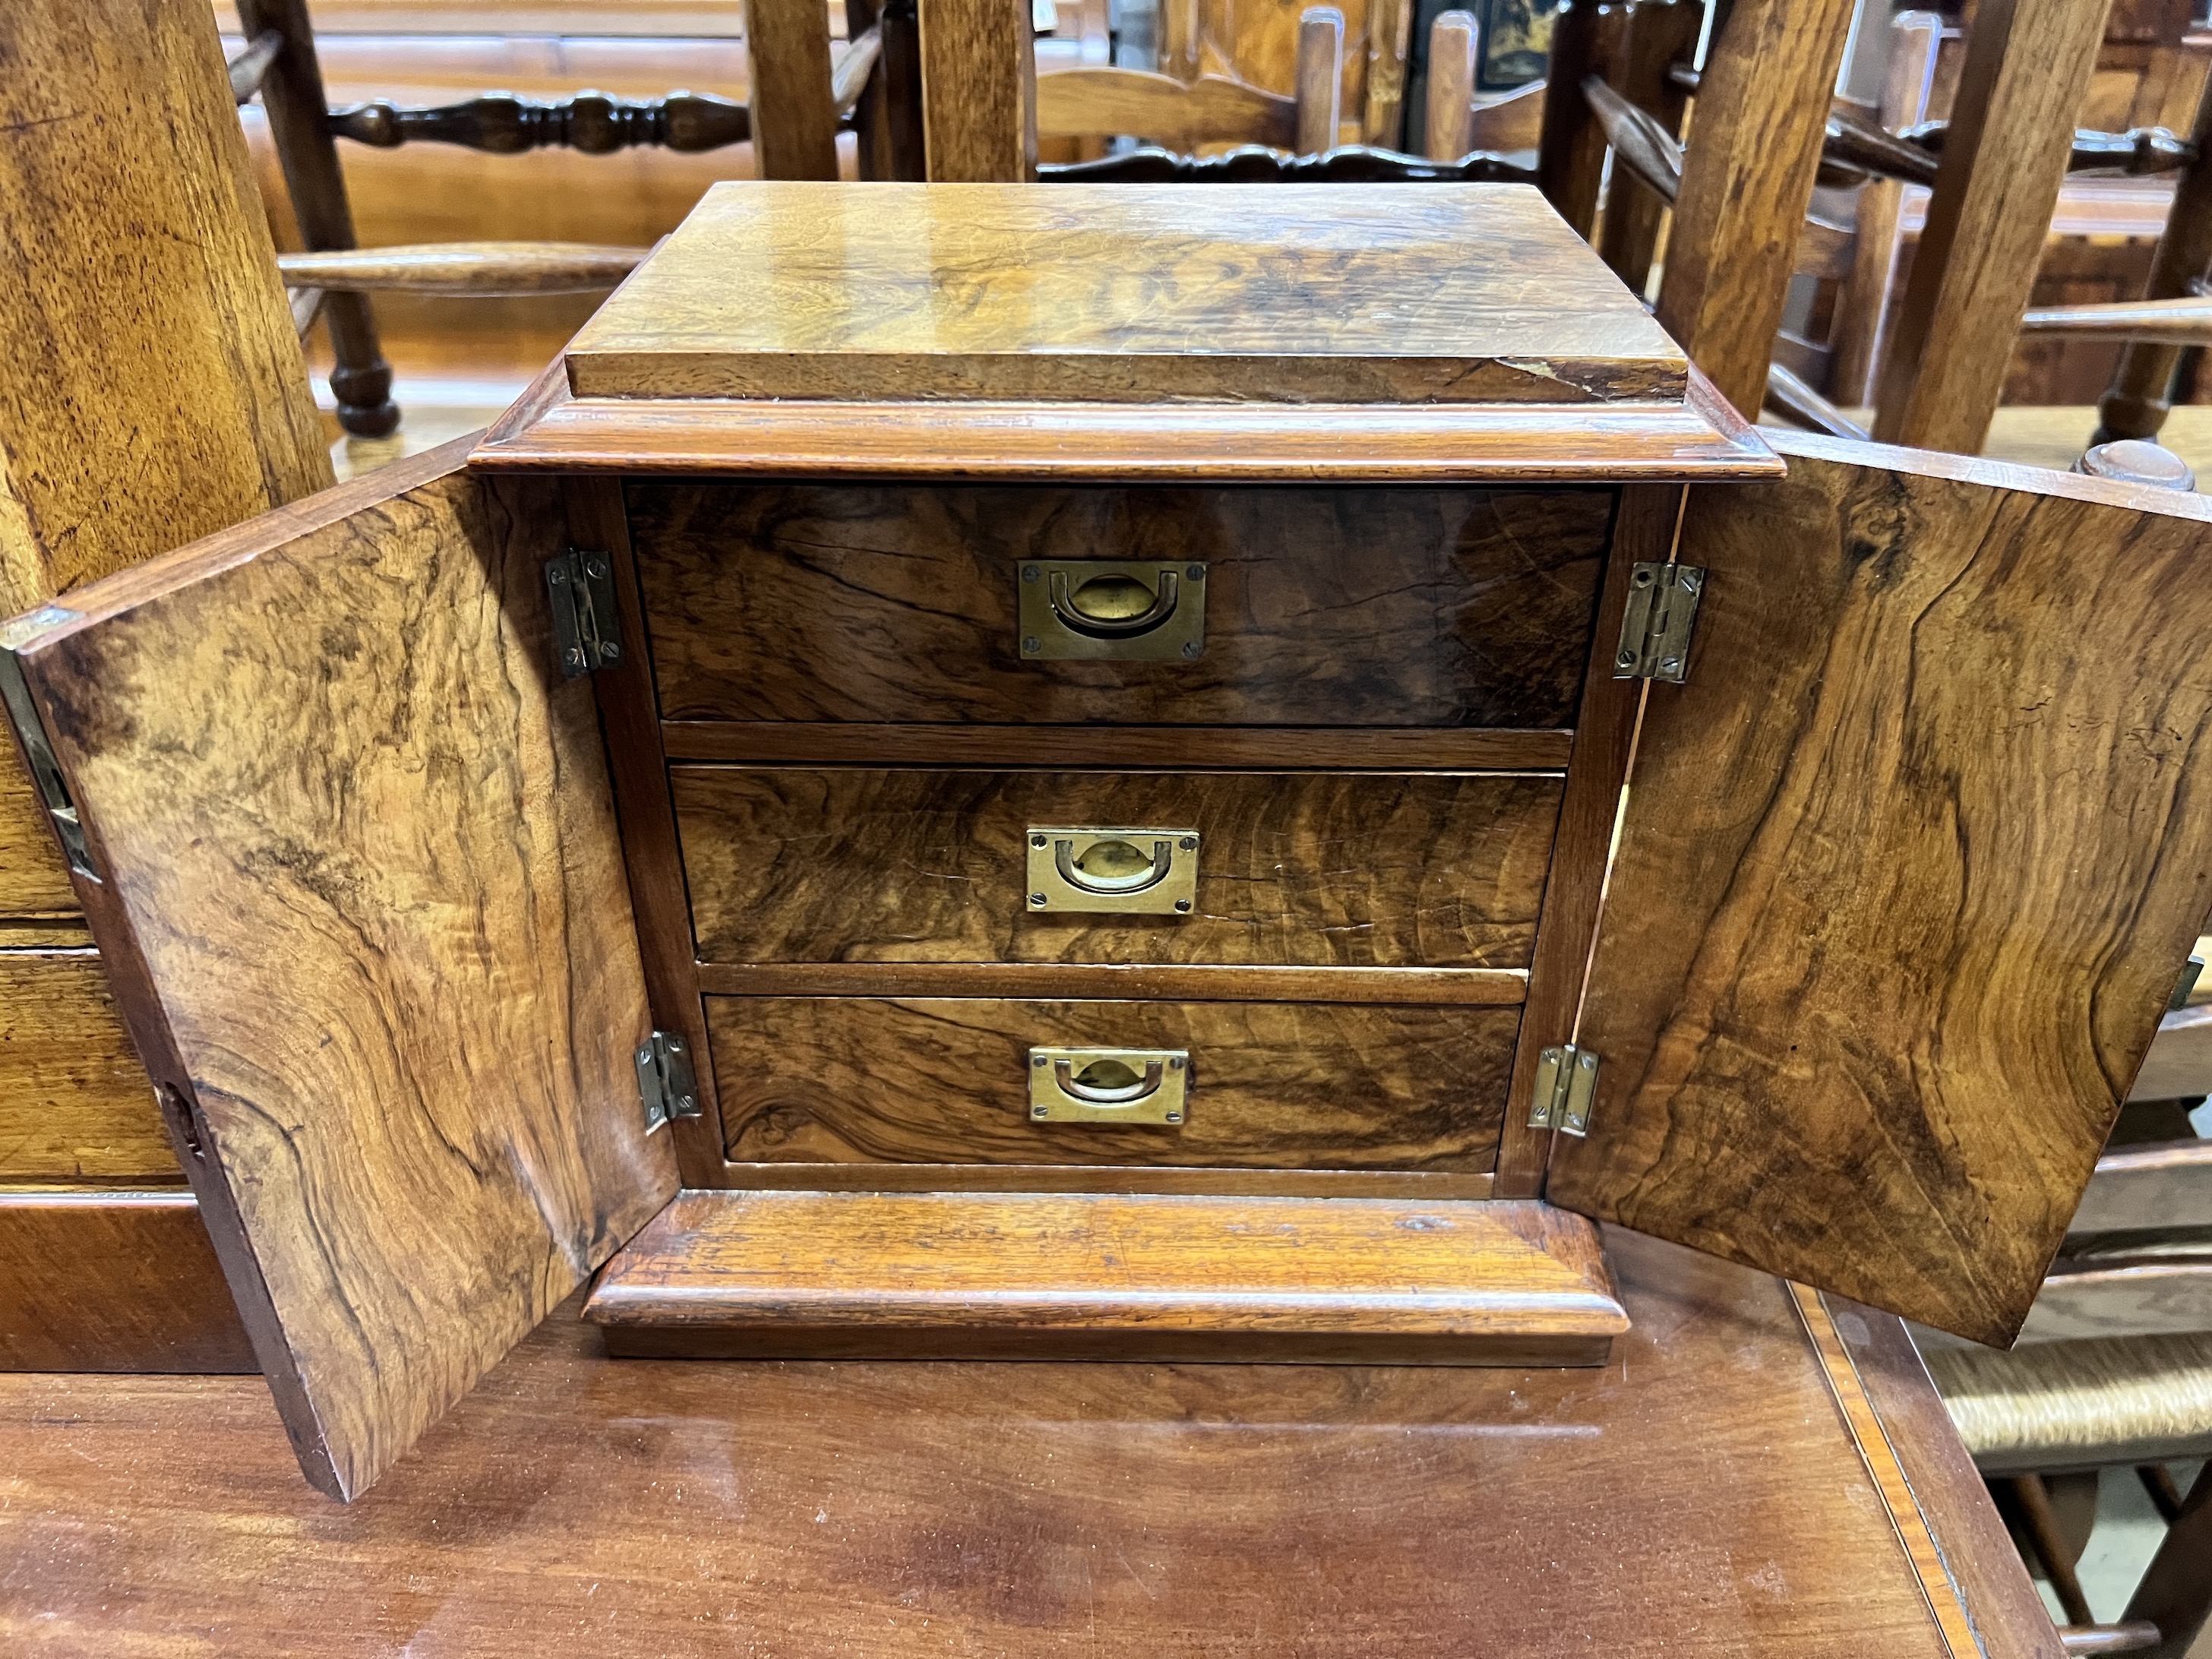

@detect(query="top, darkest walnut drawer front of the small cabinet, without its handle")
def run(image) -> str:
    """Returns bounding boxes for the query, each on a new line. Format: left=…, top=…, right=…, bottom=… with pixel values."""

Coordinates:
left=628, top=485, right=1613, bottom=728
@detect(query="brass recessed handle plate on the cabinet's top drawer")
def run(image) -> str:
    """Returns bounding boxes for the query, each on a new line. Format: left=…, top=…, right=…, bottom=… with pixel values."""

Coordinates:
left=1019, top=560, right=1206, bottom=662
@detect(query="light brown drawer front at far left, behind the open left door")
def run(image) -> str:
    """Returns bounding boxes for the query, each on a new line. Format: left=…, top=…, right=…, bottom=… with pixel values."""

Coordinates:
left=0, top=951, right=184, bottom=1186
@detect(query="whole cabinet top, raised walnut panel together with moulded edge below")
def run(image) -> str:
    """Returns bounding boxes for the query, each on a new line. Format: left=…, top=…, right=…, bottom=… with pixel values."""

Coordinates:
left=462, top=182, right=1778, bottom=480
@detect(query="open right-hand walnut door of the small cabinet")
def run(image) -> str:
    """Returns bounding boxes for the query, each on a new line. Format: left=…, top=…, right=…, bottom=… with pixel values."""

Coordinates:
left=1546, top=434, right=2212, bottom=1345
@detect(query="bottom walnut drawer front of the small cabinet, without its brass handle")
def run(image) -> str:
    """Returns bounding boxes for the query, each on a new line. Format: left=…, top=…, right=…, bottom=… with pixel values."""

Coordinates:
left=708, top=997, right=1520, bottom=1172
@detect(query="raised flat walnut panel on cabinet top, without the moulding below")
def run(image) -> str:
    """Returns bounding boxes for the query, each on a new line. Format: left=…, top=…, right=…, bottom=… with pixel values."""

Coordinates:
left=566, top=182, right=1690, bottom=405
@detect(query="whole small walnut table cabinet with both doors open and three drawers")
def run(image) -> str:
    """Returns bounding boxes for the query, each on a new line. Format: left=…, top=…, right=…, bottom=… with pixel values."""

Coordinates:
left=0, top=184, right=2212, bottom=1496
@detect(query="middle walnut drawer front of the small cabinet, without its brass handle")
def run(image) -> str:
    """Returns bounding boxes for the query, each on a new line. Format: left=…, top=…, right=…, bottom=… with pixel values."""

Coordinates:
left=672, top=769, right=1562, bottom=967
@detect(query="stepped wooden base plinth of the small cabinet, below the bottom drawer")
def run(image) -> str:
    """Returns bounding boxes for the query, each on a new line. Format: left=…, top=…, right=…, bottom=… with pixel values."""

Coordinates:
left=584, top=1193, right=1628, bottom=1365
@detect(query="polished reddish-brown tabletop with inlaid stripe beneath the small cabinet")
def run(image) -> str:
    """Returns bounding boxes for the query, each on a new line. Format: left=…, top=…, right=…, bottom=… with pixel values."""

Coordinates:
left=0, top=1232, right=2057, bottom=1659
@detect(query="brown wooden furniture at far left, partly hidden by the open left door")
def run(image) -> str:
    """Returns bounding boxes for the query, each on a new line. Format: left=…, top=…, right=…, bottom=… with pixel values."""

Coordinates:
left=0, top=0, right=332, bottom=1371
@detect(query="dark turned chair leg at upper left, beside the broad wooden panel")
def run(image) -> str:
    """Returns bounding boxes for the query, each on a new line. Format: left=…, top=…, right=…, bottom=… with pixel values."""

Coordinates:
left=239, top=0, right=400, bottom=438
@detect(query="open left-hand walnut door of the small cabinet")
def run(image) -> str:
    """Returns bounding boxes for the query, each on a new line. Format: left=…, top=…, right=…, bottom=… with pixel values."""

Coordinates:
left=0, top=444, right=677, bottom=1497
